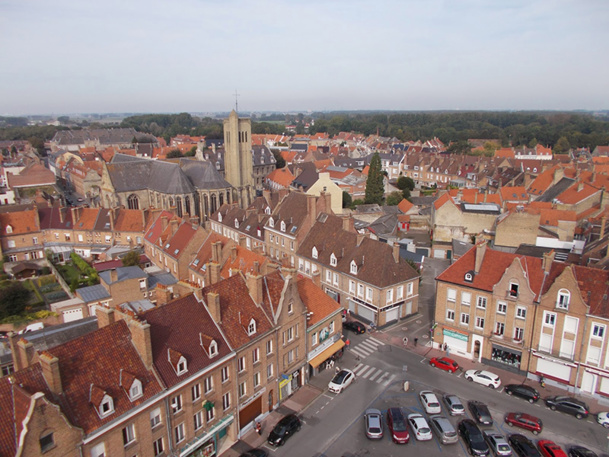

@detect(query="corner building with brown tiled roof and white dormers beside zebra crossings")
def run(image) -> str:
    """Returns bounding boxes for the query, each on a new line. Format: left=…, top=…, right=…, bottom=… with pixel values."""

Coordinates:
left=297, top=213, right=420, bottom=326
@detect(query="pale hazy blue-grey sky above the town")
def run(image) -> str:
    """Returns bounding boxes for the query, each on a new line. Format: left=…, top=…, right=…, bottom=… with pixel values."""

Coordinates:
left=0, top=0, right=609, bottom=115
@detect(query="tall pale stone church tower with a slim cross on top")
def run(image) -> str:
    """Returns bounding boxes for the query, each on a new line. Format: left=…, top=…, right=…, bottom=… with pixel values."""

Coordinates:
left=224, top=110, right=255, bottom=208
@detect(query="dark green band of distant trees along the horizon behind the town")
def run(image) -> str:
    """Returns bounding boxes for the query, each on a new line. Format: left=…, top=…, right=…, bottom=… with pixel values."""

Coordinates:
left=0, top=111, right=609, bottom=150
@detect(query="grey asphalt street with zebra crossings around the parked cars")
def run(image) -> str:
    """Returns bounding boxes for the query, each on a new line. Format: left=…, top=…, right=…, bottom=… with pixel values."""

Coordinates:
left=260, top=334, right=607, bottom=457
